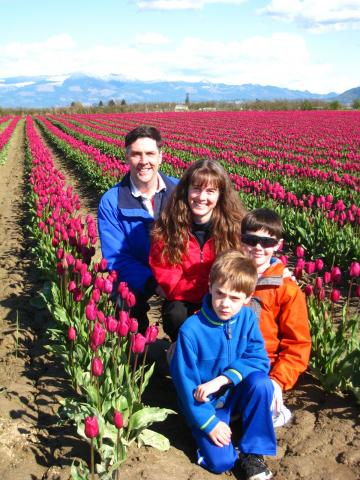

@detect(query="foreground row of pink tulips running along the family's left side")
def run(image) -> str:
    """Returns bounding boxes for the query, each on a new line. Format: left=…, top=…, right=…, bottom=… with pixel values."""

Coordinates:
left=26, top=117, right=173, bottom=479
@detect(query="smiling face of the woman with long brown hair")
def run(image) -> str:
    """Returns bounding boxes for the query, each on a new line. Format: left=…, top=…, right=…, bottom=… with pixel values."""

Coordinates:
left=188, top=184, right=220, bottom=223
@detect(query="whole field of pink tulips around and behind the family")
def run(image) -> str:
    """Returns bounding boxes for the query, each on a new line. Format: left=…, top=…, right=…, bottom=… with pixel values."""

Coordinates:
left=0, top=111, right=360, bottom=480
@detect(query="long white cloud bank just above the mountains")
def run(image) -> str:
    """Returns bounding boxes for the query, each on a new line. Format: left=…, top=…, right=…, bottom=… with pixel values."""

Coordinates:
left=0, top=32, right=360, bottom=93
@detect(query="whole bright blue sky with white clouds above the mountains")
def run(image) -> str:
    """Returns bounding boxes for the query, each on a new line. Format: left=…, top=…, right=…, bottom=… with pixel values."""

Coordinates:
left=0, top=0, right=360, bottom=93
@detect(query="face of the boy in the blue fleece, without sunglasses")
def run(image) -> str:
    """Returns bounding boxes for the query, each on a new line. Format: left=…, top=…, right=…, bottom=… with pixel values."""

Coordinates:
left=210, top=282, right=248, bottom=321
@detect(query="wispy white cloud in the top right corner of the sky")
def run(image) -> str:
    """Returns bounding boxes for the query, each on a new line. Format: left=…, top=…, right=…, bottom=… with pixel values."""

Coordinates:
left=259, top=0, right=360, bottom=33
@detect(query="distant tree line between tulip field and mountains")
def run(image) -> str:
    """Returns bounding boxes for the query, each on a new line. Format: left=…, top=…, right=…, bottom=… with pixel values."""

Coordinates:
left=0, top=95, right=360, bottom=116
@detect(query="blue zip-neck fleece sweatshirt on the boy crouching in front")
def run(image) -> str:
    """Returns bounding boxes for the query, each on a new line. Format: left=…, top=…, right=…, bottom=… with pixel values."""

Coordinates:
left=170, top=295, right=269, bottom=434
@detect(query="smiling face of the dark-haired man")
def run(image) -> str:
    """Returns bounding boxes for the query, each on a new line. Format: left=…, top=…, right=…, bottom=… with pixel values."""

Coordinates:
left=126, top=137, right=161, bottom=190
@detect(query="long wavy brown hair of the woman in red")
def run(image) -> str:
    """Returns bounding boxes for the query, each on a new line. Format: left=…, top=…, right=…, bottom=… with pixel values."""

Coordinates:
left=151, top=160, right=246, bottom=265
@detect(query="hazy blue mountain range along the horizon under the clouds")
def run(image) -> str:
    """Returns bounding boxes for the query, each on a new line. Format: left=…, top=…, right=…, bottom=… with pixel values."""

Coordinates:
left=0, top=73, right=360, bottom=108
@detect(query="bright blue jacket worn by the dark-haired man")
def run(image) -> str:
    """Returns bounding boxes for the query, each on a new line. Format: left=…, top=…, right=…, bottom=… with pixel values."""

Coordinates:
left=98, top=172, right=178, bottom=294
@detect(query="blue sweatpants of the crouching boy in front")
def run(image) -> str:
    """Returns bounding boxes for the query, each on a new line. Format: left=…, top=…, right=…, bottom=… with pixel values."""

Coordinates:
left=192, top=372, right=276, bottom=473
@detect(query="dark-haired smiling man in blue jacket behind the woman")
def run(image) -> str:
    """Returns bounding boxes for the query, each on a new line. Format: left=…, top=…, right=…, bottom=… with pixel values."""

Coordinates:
left=98, top=126, right=177, bottom=333
